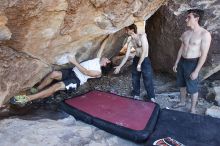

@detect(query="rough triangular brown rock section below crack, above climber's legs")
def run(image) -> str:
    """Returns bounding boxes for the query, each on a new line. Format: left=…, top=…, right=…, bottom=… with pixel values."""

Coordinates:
left=0, top=46, right=51, bottom=105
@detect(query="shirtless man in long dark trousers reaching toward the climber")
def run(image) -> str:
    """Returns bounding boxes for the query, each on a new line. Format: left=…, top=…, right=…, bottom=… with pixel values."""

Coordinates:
left=114, top=24, right=155, bottom=102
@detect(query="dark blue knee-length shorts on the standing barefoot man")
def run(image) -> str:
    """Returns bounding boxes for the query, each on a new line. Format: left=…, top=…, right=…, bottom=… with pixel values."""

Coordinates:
left=177, top=57, right=199, bottom=94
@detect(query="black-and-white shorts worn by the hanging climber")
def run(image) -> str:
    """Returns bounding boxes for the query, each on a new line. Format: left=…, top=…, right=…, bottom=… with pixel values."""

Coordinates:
left=60, top=68, right=80, bottom=91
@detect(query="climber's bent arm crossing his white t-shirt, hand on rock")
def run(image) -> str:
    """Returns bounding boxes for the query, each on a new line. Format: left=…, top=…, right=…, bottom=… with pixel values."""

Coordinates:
left=69, top=56, right=101, bottom=78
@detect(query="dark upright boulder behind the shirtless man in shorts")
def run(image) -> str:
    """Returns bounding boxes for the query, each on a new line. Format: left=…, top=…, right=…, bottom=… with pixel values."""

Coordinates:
left=146, top=0, right=220, bottom=79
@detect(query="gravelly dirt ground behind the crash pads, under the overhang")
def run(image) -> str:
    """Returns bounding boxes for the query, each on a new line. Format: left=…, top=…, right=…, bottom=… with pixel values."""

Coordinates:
left=0, top=68, right=214, bottom=118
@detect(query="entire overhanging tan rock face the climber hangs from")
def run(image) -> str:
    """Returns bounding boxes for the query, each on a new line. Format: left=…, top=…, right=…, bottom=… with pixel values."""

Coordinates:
left=0, top=0, right=165, bottom=105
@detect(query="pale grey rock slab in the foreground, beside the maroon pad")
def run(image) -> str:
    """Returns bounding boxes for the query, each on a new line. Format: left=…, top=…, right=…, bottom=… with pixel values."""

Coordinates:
left=0, top=109, right=138, bottom=146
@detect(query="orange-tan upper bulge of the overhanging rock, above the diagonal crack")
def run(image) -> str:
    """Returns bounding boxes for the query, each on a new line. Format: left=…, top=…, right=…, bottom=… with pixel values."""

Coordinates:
left=1, top=0, right=164, bottom=64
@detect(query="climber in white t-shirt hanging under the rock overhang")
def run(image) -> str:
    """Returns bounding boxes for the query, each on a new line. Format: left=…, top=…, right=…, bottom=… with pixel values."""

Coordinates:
left=10, top=39, right=110, bottom=105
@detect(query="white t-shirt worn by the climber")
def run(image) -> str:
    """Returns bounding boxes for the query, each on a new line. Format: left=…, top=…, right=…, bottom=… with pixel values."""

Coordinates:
left=73, top=58, right=101, bottom=85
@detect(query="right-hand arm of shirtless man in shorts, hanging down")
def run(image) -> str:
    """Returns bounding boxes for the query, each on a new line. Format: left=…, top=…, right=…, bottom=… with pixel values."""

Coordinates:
left=190, top=32, right=212, bottom=80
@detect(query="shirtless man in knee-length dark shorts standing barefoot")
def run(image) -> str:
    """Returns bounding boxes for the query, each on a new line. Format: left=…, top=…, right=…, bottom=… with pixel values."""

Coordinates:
left=173, top=9, right=211, bottom=113
